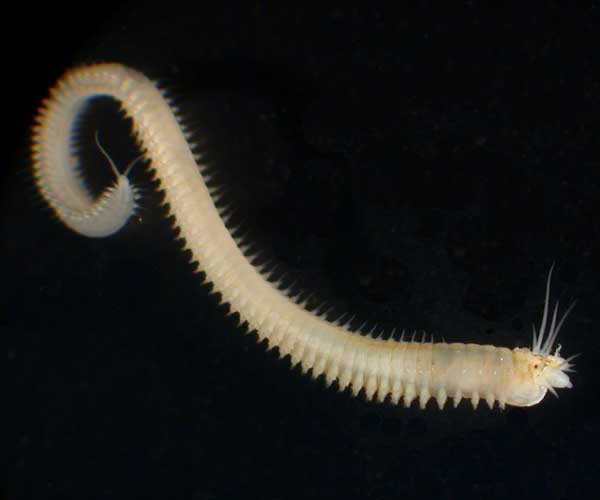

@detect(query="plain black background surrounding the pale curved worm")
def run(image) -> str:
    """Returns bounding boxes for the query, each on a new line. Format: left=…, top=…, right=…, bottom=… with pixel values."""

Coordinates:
left=0, top=1, right=600, bottom=499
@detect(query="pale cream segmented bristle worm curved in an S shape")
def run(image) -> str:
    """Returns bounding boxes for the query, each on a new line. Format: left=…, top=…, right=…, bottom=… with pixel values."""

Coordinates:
left=32, top=64, right=572, bottom=408
